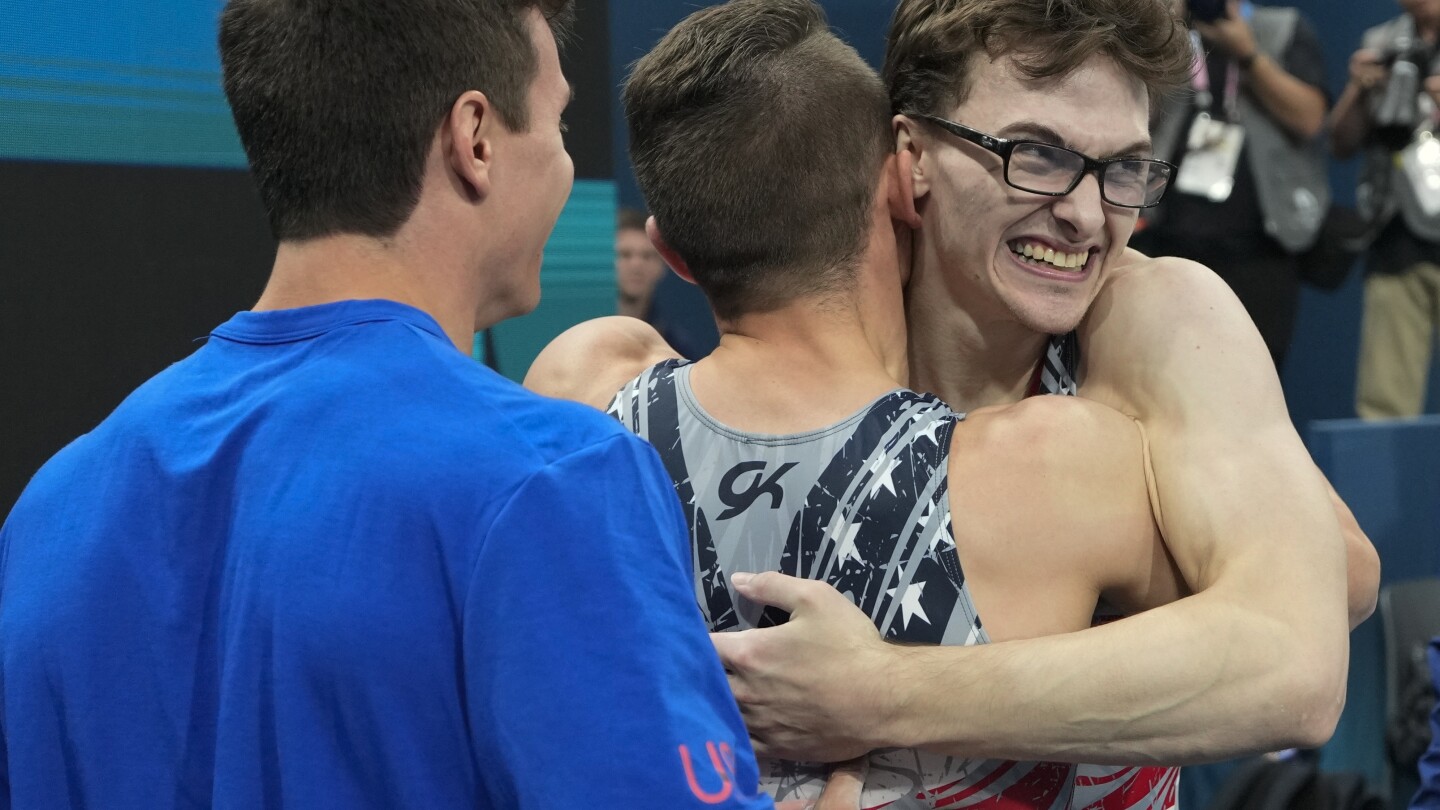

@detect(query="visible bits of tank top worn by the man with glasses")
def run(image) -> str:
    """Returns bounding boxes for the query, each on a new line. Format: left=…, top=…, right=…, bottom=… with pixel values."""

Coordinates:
left=1027, top=331, right=1179, bottom=810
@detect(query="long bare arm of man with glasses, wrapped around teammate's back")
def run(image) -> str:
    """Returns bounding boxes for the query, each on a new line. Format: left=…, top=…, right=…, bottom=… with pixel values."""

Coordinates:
left=713, top=261, right=1348, bottom=764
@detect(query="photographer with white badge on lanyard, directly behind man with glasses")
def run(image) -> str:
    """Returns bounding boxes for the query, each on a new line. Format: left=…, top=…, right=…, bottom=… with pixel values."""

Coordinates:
left=1130, top=0, right=1329, bottom=368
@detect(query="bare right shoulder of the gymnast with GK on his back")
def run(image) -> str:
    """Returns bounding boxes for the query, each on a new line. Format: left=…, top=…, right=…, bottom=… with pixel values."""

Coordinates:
left=949, top=396, right=1179, bottom=638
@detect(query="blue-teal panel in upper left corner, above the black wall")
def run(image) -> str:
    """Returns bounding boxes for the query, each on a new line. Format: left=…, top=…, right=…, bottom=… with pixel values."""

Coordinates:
left=0, top=0, right=245, bottom=169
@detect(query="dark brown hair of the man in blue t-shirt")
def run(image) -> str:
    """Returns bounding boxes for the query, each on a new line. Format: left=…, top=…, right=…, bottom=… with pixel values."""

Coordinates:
left=220, top=0, right=569, bottom=241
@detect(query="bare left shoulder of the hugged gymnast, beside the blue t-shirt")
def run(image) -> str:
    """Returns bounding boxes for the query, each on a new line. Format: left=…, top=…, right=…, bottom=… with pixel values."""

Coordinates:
left=526, top=316, right=680, bottom=408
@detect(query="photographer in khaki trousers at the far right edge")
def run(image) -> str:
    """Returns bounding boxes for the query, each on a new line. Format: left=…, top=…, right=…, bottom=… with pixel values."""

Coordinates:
left=1332, top=0, right=1440, bottom=419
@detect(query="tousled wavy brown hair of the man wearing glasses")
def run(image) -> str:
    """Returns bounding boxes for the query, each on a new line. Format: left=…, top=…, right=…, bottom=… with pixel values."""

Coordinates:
left=884, top=0, right=1194, bottom=121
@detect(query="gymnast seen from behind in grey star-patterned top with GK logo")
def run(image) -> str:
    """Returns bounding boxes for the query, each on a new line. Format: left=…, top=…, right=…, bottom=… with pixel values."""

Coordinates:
left=526, top=0, right=1181, bottom=807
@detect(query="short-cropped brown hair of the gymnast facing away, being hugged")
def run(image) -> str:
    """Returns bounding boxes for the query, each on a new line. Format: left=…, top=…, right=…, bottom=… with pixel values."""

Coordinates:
left=624, top=0, right=891, bottom=319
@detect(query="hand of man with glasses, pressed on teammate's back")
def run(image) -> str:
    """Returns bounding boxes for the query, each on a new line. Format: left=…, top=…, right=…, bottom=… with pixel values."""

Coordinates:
left=710, top=571, right=900, bottom=762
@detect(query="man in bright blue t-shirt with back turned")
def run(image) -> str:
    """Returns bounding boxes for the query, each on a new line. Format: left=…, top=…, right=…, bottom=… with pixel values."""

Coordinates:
left=0, top=0, right=769, bottom=810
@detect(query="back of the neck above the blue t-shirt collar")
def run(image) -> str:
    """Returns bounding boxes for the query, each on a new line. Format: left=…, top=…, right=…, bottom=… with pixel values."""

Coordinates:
left=253, top=223, right=480, bottom=352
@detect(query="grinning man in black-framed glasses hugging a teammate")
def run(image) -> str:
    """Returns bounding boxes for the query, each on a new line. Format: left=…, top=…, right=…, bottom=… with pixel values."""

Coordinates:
left=714, top=0, right=1378, bottom=807
